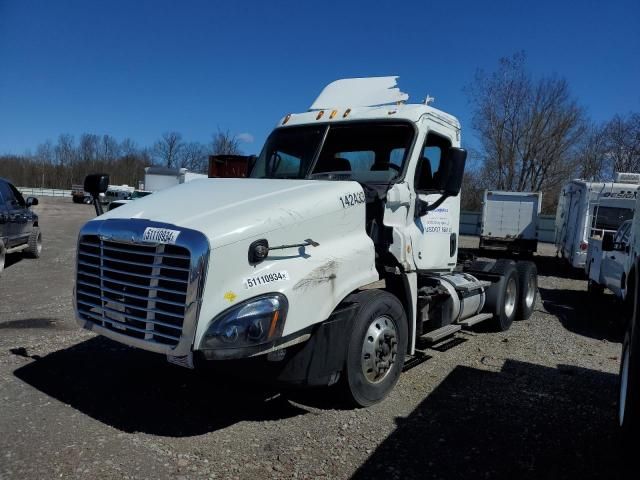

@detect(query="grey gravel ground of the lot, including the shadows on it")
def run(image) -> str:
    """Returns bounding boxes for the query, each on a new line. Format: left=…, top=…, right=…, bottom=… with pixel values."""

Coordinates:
left=0, top=198, right=621, bottom=480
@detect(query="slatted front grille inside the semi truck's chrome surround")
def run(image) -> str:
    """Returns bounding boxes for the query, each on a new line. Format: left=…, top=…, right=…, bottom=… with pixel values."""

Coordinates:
left=76, top=235, right=191, bottom=346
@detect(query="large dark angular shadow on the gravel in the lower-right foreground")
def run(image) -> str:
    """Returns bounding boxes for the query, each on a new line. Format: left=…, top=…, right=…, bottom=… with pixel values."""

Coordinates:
left=352, top=360, right=621, bottom=480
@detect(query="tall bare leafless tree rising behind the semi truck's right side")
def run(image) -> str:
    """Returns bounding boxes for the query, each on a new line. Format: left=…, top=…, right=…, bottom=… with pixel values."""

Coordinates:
left=467, top=53, right=585, bottom=196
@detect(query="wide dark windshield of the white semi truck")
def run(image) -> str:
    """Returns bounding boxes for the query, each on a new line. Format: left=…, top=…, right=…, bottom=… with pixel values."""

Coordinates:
left=251, top=122, right=414, bottom=183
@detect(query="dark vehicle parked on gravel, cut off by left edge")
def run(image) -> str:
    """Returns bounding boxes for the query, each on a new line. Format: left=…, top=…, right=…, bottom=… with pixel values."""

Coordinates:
left=0, top=178, right=42, bottom=273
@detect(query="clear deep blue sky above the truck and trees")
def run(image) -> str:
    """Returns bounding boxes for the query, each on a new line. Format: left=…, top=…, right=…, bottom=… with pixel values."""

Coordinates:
left=0, top=0, right=640, bottom=154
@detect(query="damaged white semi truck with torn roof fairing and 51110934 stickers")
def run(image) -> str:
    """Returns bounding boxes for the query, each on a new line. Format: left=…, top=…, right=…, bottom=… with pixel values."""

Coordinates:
left=74, top=77, right=537, bottom=406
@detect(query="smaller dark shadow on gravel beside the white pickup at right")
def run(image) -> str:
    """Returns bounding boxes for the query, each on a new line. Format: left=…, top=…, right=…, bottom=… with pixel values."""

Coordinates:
left=538, top=288, right=624, bottom=342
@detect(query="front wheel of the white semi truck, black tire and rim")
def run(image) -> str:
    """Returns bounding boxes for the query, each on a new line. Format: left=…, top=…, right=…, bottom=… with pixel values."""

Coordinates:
left=344, top=290, right=408, bottom=407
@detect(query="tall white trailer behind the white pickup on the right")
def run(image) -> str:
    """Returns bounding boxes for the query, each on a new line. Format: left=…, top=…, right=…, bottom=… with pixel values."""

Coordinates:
left=556, top=173, right=640, bottom=268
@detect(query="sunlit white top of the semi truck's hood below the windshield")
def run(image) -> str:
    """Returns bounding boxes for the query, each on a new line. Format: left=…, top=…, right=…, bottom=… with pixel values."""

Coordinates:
left=97, top=178, right=364, bottom=248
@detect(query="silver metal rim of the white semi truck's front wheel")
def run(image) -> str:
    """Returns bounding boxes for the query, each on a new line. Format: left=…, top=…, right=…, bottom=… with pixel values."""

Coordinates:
left=360, top=316, right=398, bottom=383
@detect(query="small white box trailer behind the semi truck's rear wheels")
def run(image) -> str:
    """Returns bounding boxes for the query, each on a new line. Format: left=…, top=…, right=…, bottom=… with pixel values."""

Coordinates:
left=480, top=190, right=542, bottom=255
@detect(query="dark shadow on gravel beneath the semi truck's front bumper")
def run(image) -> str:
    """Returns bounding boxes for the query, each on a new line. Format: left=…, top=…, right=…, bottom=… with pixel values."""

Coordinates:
left=12, top=337, right=307, bottom=437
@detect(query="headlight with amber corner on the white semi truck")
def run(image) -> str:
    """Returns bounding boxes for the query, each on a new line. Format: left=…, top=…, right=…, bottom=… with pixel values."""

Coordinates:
left=202, top=293, right=289, bottom=349
